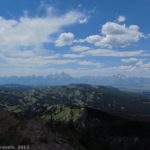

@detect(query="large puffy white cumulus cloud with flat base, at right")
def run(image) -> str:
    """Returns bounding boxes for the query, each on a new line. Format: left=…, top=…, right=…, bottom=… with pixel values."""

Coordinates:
left=78, top=22, right=144, bottom=48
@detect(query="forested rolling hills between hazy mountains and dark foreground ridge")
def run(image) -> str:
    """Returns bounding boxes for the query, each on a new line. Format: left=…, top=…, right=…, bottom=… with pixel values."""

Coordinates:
left=0, top=84, right=150, bottom=114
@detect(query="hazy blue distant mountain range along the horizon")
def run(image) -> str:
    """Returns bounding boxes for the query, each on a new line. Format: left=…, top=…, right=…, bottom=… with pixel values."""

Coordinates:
left=0, top=73, right=150, bottom=91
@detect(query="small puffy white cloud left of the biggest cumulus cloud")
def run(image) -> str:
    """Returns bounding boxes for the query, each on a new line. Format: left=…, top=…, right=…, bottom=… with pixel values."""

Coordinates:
left=55, top=32, right=74, bottom=47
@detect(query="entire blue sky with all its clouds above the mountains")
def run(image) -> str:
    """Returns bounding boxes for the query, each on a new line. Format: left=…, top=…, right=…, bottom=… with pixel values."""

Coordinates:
left=0, top=0, right=150, bottom=77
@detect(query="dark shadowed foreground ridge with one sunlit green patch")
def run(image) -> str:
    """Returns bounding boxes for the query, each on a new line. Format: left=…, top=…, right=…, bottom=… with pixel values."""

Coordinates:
left=0, top=105, right=150, bottom=150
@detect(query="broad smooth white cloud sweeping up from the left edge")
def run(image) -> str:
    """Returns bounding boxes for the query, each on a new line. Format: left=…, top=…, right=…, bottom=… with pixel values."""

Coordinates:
left=0, top=11, right=83, bottom=48
